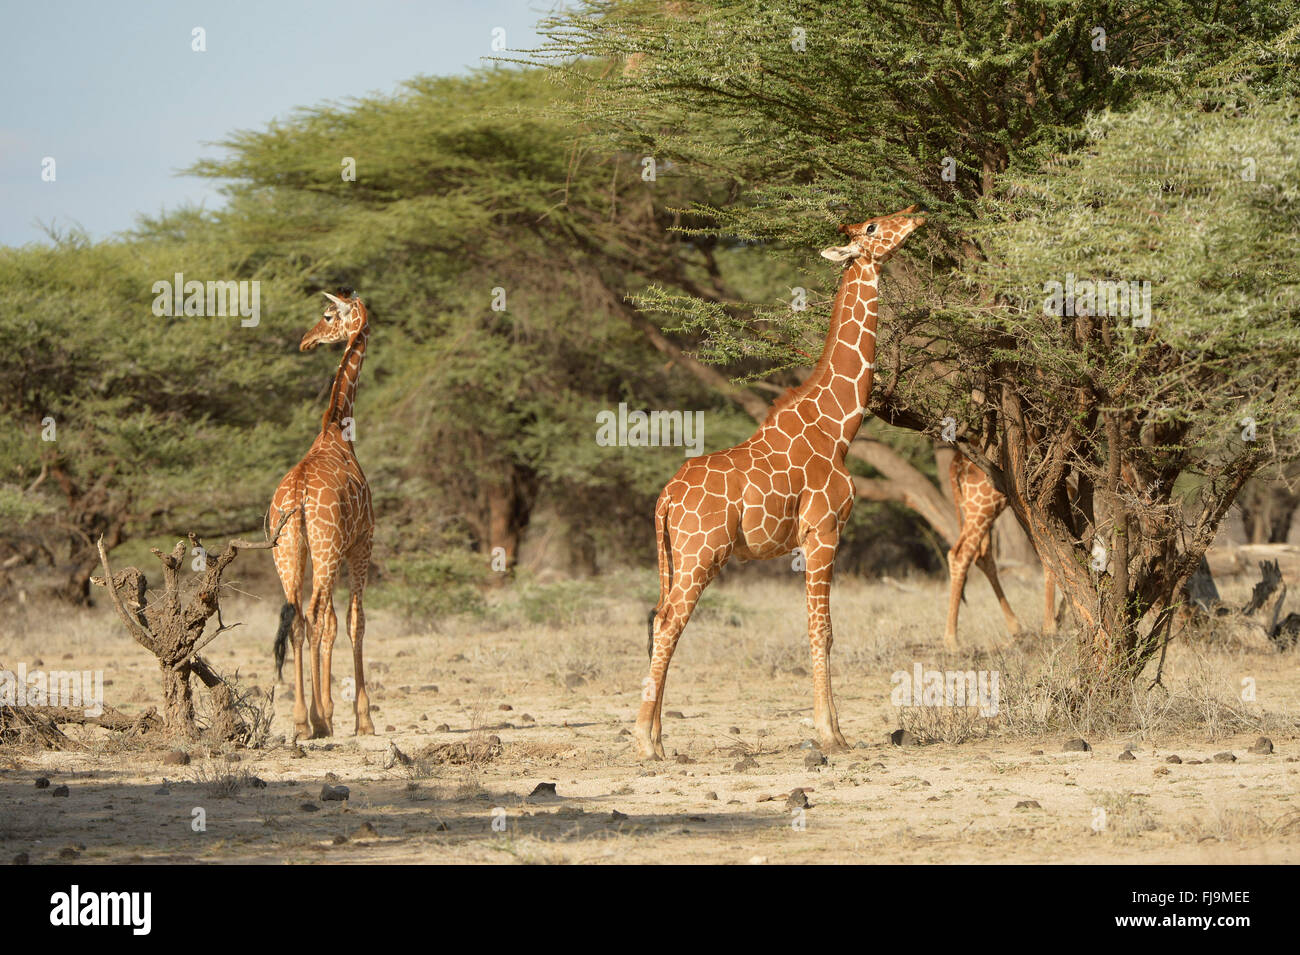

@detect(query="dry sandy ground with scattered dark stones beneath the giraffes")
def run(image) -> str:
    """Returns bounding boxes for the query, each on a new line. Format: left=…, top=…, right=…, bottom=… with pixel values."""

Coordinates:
left=0, top=561, right=1300, bottom=864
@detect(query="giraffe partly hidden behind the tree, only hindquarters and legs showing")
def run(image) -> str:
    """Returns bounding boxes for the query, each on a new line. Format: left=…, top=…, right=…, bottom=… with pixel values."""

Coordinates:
left=944, top=452, right=1056, bottom=650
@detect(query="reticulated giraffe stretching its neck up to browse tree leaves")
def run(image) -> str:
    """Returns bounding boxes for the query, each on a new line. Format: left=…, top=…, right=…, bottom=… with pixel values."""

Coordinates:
left=636, top=205, right=926, bottom=759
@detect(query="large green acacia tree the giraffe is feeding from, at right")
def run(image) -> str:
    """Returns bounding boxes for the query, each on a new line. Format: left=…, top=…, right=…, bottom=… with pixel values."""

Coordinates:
left=534, top=0, right=1297, bottom=680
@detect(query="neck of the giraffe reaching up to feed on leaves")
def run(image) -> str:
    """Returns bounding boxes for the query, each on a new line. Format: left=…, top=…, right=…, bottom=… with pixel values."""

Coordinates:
left=803, top=257, right=879, bottom=447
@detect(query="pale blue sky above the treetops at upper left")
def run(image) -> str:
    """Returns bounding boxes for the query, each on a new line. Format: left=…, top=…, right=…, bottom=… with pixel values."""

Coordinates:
left=0, top=0, right=559, bottom=246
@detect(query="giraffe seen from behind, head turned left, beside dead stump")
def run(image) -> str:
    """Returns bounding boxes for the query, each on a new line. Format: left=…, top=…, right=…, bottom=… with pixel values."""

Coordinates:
left=268, top=292, right=374, bottom=738
